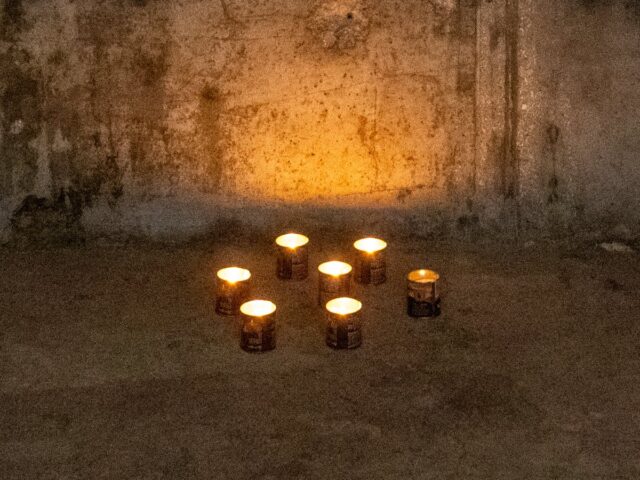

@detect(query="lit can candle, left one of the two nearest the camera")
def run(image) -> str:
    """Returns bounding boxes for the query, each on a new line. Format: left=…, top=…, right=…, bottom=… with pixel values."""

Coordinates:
left=240, top=300, right=276, bottom=352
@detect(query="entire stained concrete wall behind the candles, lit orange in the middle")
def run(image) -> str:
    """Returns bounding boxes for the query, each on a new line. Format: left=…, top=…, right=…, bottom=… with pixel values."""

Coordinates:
left=0, top=0, right=640, bottom=239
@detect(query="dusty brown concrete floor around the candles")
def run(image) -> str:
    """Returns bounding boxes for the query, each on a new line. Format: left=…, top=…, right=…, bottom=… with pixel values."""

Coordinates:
left=0, top=241, right=640, bottom=480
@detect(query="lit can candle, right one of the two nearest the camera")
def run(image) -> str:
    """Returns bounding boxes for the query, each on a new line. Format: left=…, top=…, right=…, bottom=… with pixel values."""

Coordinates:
left=326, top=297, right=362, bottom=349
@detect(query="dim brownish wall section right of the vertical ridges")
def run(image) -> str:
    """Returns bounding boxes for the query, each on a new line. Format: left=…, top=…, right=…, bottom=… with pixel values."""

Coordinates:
left=517, top=0, right=640, bottom=235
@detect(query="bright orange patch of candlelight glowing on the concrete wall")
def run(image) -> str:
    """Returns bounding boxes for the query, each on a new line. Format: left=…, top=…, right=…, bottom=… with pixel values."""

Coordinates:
left=208, top=79, right=451, bottom=206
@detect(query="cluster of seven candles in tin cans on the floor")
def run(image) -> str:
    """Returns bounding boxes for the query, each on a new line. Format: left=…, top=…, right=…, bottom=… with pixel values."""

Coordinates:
left=216, top=233, right=440, bottom=352
